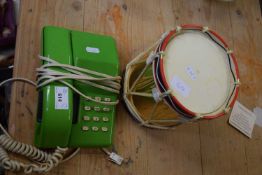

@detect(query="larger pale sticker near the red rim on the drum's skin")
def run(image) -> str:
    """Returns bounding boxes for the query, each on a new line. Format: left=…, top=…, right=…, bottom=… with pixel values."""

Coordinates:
left=171, top=76, right=191, bottom=97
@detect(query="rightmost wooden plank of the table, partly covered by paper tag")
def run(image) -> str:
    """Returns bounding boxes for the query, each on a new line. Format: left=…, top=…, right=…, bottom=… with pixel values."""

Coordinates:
left=230, top=0, right=262, bottom=175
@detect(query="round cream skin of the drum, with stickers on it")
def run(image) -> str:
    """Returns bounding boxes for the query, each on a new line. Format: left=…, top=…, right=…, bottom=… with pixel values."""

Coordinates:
left=158, top=31, right=234, bottom=114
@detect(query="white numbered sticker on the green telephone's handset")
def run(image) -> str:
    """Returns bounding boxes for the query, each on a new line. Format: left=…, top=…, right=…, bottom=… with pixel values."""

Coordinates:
left=55, top=86, right=69, bottom=109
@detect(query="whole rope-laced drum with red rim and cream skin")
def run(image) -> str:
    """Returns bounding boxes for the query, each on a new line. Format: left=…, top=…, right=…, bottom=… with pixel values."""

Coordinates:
left=124, top=25, right=239, bottom=128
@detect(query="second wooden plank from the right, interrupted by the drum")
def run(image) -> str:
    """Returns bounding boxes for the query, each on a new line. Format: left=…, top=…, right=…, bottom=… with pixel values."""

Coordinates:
left=200, top=2, right=250, bottom=175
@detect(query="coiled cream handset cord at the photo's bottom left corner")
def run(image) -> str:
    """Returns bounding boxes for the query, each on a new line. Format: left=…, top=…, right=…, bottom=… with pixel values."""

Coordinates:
left=0, top=124, right=68, bottom=174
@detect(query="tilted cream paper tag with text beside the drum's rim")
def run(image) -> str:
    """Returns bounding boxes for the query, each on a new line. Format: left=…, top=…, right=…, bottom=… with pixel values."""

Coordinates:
left=229, top=101, right=256, bottom=138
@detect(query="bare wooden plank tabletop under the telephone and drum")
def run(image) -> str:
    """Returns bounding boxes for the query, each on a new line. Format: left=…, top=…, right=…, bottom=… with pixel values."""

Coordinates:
left=9, top=0, right=262, bottom=175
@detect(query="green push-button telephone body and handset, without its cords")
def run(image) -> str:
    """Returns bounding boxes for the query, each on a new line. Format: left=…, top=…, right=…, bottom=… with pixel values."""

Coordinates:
left=35, top=26, right=119, bottom=148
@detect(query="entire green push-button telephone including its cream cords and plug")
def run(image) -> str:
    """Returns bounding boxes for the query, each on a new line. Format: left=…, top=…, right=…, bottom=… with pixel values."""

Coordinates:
left=0, top=26, right=124, bottom=173
